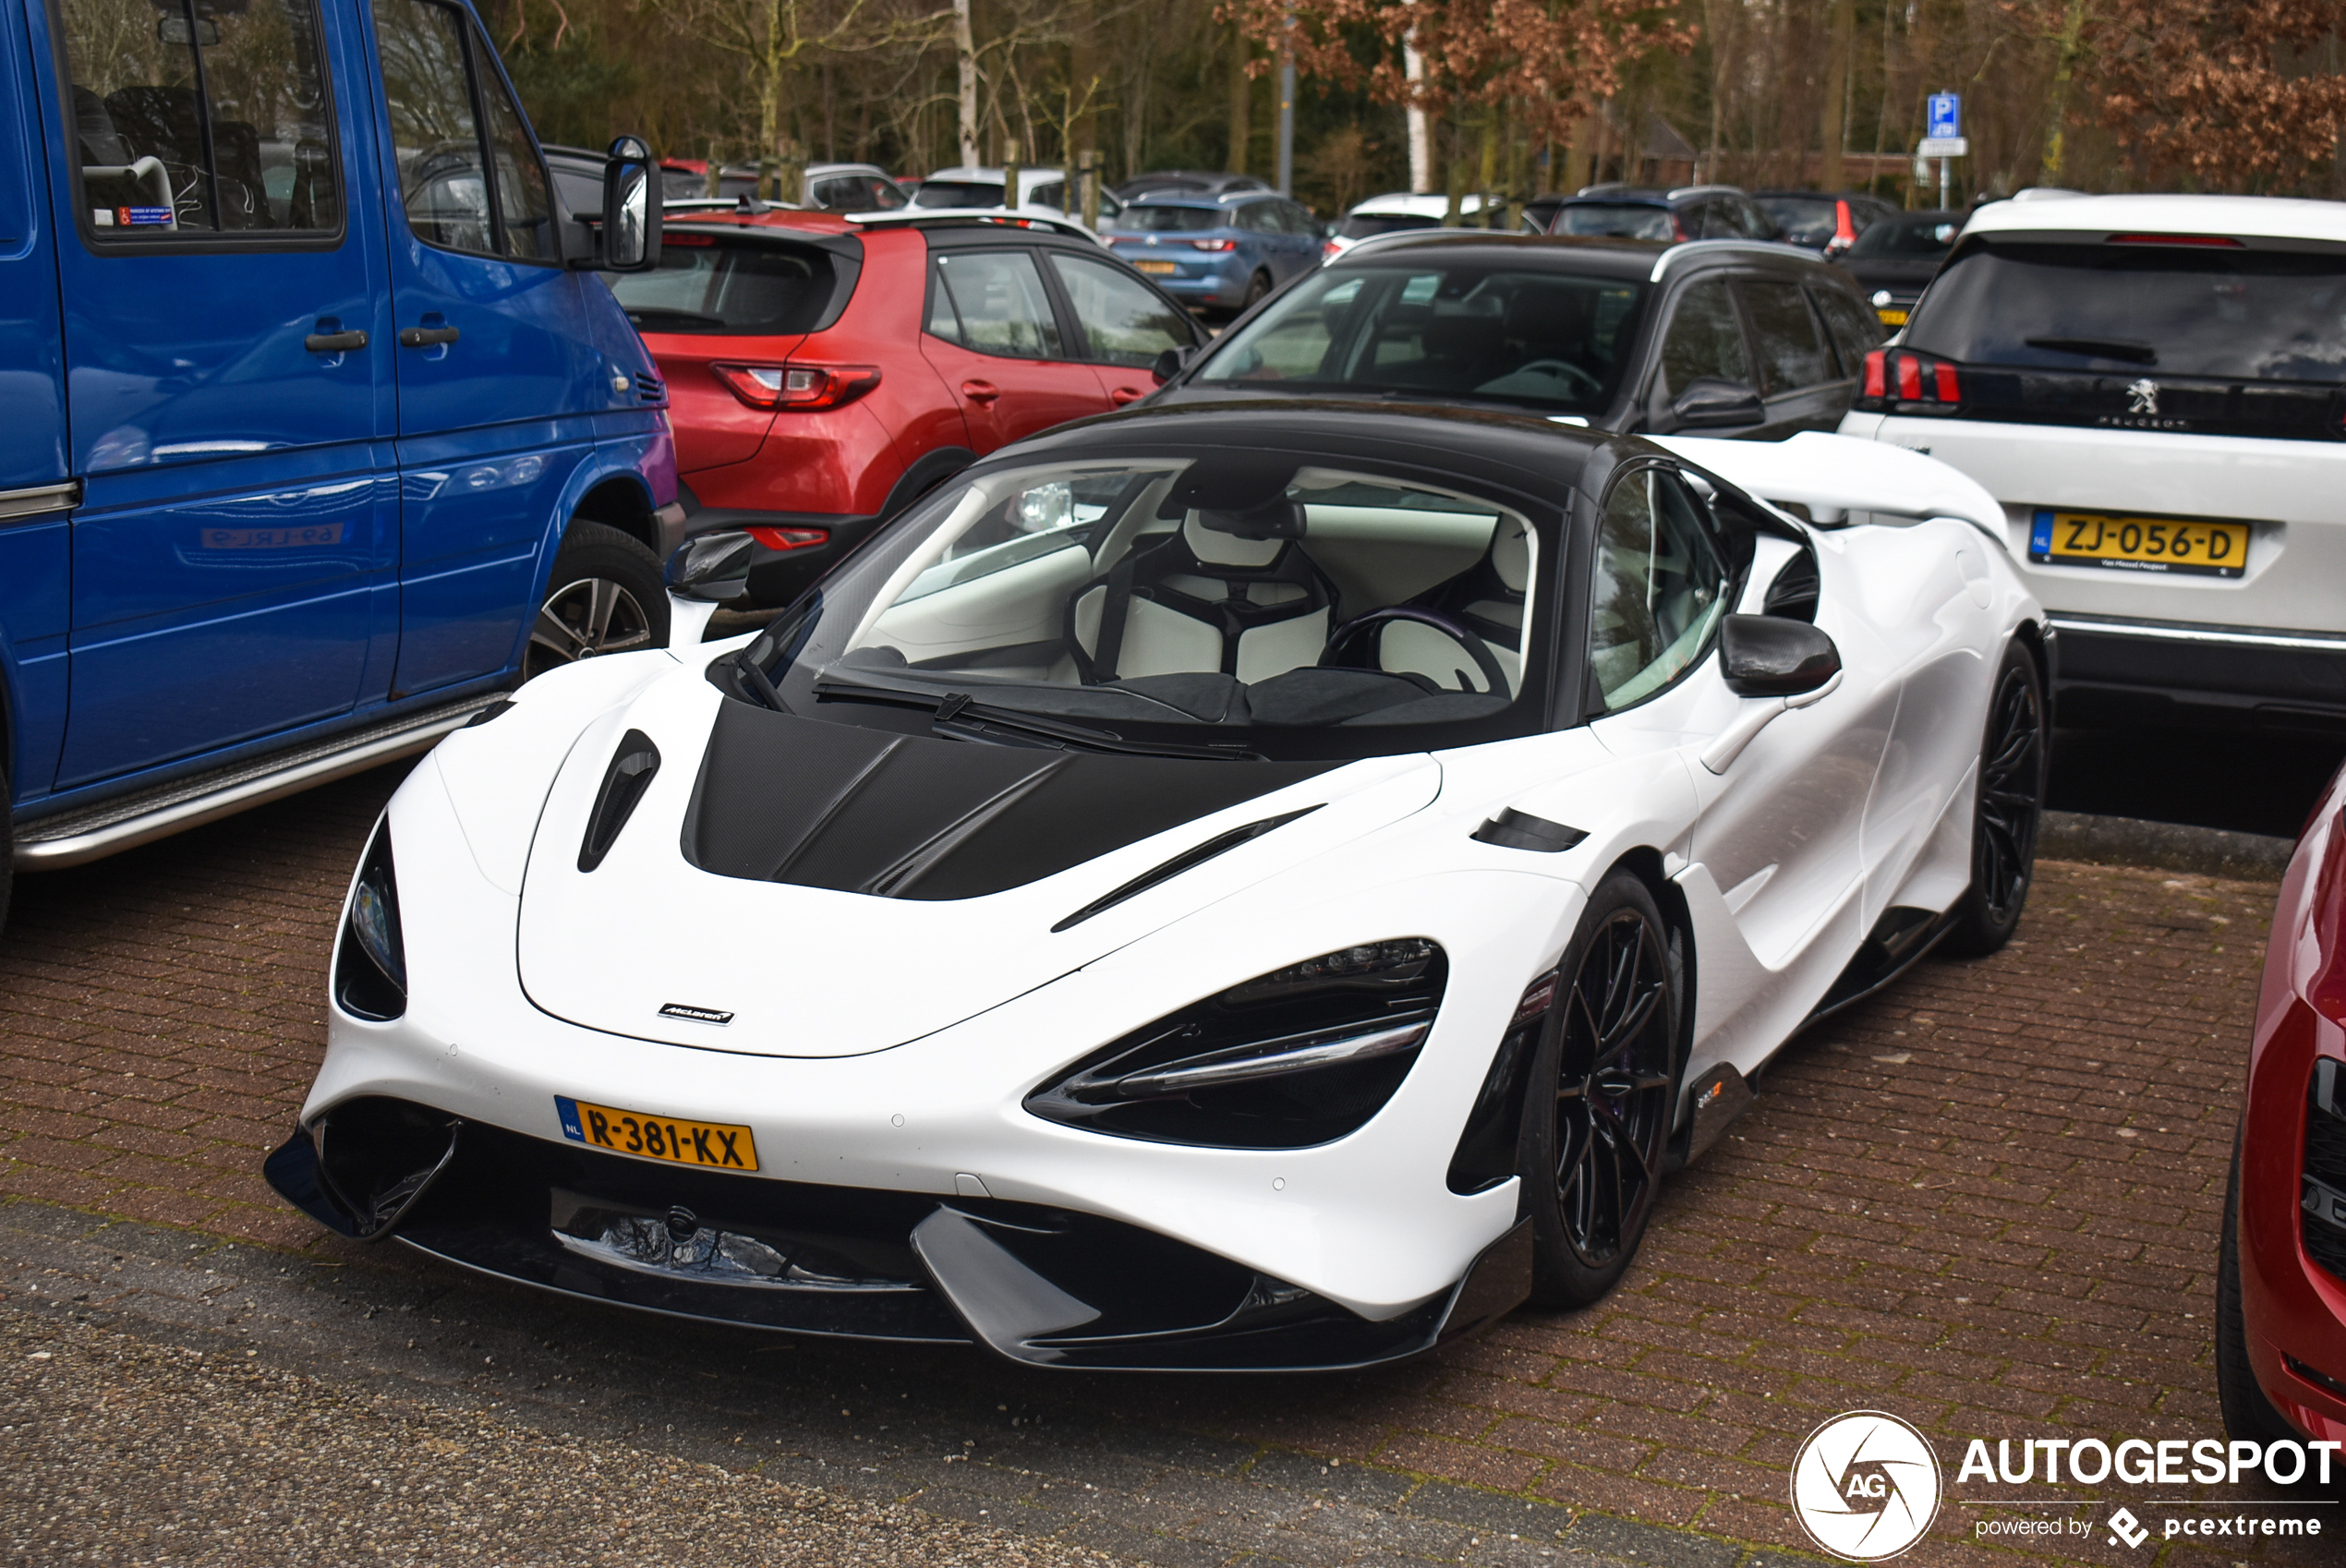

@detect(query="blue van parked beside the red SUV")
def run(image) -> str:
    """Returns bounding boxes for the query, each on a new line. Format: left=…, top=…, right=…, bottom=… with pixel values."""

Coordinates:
left=0, top=0, right=683, bottom=914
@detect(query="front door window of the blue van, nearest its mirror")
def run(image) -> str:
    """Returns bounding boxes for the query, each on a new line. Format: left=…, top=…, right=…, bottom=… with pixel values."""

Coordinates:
left=375, top=0, right=556, bottom=260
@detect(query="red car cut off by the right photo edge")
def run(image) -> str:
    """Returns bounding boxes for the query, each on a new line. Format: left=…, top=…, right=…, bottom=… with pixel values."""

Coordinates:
left=2215, top=771, right=2346, bottom=1443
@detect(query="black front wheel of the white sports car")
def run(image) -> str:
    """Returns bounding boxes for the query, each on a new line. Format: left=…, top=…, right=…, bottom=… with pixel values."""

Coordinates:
left=1520, top=872, right=1682, bottom=1308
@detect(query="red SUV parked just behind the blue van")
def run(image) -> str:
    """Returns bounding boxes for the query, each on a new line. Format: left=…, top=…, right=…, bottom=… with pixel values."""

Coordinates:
left=612, top=204, right=1203, bottom=605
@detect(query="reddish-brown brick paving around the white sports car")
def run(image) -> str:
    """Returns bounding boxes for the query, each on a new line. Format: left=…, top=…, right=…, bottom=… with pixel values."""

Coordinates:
left=0, top=774, right=2317, bottom=1563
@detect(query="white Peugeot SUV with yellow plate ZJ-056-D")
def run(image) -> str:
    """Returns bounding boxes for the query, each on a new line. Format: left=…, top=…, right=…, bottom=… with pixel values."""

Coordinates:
left=1842, top=197, right=2346, bottom=729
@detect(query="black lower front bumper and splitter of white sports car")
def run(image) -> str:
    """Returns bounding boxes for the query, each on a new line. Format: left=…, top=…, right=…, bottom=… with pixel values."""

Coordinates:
left=268, top=1105, right=1532, bottom=1371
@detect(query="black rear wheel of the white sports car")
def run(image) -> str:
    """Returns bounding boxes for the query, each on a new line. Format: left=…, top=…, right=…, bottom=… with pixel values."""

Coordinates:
left=1947, top=642, right=2050, bottom=957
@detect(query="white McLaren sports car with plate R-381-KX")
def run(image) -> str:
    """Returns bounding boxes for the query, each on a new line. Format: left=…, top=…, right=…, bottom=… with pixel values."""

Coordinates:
left=268, top=404, right=2050, bottom=1369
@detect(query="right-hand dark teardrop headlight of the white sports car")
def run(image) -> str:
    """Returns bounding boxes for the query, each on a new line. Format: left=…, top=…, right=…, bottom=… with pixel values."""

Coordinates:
left=1025, top=937, right=1450, bottom=1149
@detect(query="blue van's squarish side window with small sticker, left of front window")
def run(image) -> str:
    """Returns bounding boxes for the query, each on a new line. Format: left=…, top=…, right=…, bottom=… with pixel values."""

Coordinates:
left=59, top=0, right=343, bottom=244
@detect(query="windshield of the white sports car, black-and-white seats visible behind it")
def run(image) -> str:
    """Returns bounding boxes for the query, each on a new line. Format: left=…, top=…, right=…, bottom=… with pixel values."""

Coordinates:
left=744, top=450, right=1553, bottom=757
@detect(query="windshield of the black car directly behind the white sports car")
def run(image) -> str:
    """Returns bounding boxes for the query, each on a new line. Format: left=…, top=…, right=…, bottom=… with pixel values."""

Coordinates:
left=1196, top=260, right=1645, bottom=415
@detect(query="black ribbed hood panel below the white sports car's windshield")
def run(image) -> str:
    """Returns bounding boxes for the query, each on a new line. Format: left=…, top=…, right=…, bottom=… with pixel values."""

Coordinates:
left=683, top=703, right=1339, bottom=900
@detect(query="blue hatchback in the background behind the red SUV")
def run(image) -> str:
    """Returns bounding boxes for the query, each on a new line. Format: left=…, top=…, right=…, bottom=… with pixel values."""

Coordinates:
left=1107, top=190, right=1325, bottom=309
